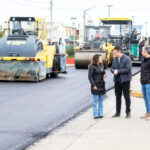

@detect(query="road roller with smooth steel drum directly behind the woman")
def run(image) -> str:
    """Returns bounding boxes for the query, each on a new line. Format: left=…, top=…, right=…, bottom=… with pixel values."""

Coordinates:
left=75, top=26, right=109, bottom=68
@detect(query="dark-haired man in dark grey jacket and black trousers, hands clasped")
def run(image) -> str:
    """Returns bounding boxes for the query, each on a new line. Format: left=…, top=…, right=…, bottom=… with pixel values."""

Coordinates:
left=111, top=46, right=132, bottom=118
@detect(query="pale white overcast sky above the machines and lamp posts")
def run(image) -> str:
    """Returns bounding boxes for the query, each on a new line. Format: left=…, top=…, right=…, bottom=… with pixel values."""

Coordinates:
left=0, top=0, right=150, bottom=34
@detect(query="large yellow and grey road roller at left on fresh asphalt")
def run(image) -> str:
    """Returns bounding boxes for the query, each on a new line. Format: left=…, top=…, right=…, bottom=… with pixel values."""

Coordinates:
left=0, top=17, right=66, bottom=81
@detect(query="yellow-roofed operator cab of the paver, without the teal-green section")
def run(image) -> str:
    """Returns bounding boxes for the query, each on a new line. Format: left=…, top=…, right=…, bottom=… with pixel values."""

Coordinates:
left=100, top=18, right=132, bottom=55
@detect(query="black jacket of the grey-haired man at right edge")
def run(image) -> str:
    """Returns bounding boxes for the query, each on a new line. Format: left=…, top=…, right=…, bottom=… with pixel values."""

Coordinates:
left=141, top=58, right=150, bottom=84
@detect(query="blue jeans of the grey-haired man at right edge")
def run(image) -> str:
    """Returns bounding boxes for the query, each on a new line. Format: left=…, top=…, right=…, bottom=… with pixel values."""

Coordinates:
left=142, top=84, right=150, bottom=113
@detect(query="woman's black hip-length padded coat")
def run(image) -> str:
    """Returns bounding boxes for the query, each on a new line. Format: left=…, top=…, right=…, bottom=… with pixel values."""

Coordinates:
left=88, top=64, right=105, bottom=95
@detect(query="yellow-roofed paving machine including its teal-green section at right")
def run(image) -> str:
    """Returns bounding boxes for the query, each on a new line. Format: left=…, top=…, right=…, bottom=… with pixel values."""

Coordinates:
left=100, top=18, right=141, bottom=64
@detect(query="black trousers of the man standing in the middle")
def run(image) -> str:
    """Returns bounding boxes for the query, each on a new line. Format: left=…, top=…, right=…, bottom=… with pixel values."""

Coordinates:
left=115, top=82, right=131, bottom=114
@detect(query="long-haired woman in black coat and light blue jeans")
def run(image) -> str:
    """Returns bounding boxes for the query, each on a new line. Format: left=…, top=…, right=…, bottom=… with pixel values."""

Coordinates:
left=88, top=54, right=106, bottom=119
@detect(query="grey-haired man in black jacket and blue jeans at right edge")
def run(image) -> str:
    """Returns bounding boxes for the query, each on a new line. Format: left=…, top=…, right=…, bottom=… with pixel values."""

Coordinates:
left=141, top=46, right=150, bottom=120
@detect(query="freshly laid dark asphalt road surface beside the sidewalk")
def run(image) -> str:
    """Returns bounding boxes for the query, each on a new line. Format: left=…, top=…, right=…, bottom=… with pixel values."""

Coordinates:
left=0, top=67, right=139, bottom=150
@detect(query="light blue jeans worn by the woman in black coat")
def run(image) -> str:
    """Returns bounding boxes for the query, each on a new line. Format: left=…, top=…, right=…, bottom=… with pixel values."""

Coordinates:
left=93, top=95, right=104, bottom=117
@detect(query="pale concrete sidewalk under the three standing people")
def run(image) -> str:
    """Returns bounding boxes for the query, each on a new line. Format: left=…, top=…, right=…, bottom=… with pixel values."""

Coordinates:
left=27, top=74, right=150, bottom=150
